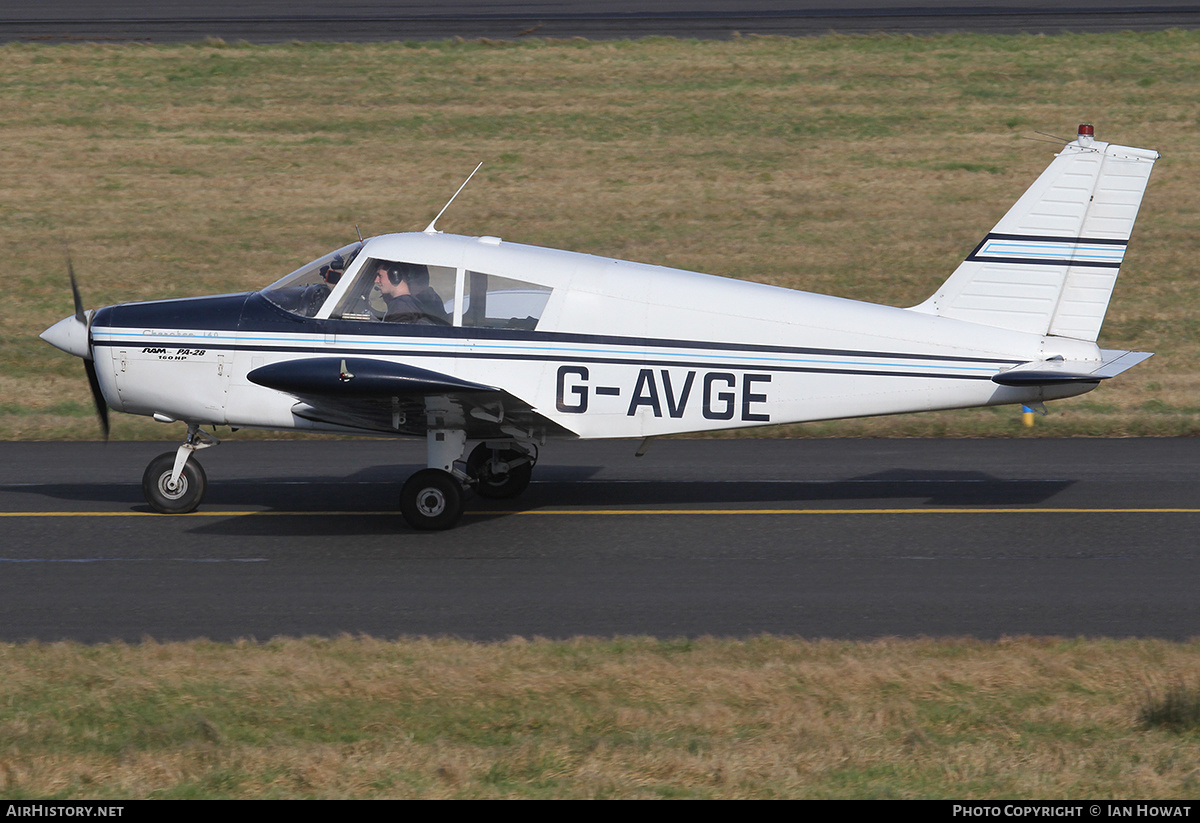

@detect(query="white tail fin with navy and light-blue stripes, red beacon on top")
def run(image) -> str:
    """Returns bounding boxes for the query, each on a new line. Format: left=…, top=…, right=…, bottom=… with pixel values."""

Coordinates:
left=912, top=125, right=1158, bottom=342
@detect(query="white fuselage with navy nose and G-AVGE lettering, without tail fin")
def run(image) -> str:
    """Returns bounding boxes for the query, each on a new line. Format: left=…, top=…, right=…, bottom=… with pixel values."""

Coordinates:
left=84, top=234, right=1100, bottom=438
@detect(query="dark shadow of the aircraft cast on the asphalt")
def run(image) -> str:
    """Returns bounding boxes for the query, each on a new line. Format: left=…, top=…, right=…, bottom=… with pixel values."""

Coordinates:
left=0, top=467, right=1075, bottom=535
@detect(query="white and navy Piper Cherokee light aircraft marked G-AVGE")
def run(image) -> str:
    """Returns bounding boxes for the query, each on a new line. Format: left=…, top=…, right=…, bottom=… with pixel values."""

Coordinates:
left=42, top=125, right=1158, bottom=529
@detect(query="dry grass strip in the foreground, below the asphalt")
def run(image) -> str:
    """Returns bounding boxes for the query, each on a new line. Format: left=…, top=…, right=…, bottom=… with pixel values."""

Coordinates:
left=0, top=637, right=1200, bottom=799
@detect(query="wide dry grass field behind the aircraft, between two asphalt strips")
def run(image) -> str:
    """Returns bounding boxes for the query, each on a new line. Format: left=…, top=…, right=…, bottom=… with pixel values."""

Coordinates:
left=0, top=31, right=1200, bottom=439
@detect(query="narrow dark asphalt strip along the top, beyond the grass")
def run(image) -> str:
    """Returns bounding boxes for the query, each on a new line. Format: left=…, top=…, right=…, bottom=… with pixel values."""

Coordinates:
left=0, top=0, right=1200, bottom=43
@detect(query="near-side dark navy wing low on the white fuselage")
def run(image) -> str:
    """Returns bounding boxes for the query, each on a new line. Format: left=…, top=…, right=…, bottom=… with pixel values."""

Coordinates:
left=246, top=358, right=574, bottom=439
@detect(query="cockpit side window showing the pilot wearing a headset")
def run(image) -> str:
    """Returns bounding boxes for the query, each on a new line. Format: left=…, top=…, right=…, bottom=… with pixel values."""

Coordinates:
left=331, top=259, right=457, bottom=325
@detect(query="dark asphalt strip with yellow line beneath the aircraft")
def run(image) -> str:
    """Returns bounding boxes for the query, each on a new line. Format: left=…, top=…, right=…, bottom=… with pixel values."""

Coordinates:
left=0, top=439, right=1200, bottom=642
